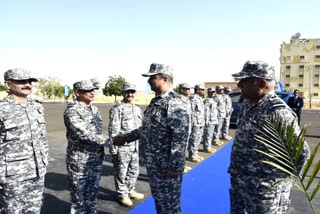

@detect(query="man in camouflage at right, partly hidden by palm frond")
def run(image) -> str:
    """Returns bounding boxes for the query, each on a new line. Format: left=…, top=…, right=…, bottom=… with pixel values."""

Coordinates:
left=228, top=61, right=309, bottom=214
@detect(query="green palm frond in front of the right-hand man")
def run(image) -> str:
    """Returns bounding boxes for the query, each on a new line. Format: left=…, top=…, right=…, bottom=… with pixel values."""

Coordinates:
left=255, top=115, right=320, bottom=213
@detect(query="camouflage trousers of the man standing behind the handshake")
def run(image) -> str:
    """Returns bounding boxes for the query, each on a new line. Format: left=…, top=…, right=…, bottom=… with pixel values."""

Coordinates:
left=112, top=146, right=139, bottom=196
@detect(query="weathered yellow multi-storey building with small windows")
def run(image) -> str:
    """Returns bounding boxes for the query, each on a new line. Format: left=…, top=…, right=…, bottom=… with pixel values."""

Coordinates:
left=280, top=33, right=320, bottom=104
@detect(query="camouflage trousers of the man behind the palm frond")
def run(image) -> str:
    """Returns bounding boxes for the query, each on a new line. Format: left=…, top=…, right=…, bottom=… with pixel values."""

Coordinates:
left=230, top=175, right=292, bottom=214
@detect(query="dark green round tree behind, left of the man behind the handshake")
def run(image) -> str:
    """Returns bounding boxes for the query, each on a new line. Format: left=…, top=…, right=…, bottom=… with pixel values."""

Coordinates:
left=102, top=75, right=126, bottom=102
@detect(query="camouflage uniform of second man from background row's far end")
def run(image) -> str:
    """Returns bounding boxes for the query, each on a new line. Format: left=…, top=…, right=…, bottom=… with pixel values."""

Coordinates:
left=212, top=94, right=227, bottom=144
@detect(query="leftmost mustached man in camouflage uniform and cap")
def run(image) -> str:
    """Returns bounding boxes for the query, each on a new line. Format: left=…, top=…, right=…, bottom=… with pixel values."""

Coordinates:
left=0, top=68, right=48, bottom=214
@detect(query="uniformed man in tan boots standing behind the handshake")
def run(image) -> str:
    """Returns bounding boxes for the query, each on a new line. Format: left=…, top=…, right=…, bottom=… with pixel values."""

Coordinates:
left=109, top=83, right=144, bottom=207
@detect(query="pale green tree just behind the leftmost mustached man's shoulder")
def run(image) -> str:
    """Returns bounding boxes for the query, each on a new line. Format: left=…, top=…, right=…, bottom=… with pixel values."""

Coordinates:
left=38, top=77, right=64, bottom=99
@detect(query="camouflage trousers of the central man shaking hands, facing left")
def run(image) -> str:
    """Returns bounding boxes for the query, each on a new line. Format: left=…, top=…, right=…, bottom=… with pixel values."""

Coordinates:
left=147, top=166, right=182, bottom=214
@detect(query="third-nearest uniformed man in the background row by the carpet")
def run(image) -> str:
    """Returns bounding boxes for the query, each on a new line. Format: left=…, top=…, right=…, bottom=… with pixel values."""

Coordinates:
left=203, top=88, right=218, bottom=154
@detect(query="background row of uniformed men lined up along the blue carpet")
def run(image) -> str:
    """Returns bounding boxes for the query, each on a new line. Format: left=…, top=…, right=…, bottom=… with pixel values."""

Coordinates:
left=179, top=83, right=232, bottom=166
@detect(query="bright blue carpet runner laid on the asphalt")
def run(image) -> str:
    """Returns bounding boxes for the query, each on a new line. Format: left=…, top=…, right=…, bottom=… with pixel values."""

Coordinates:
left=129, top=142, right=232, bottom=214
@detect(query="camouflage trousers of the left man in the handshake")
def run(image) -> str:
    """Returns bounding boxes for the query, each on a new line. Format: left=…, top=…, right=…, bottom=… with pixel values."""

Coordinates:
left=67, top=154, right=103, bottom=214
